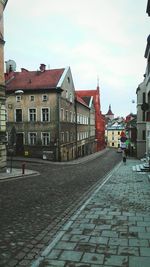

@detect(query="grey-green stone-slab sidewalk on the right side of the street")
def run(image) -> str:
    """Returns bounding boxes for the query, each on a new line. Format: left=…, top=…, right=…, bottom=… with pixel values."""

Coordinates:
left=31, top=159, right=150, bottom=267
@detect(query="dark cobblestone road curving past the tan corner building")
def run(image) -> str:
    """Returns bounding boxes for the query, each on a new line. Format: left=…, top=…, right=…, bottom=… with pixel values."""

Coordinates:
left=0, top=150, right=121, bottom=267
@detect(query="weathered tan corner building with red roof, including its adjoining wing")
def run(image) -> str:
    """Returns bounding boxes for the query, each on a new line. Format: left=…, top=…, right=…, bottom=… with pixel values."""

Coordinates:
left=6, top=64, right=95, bottom=161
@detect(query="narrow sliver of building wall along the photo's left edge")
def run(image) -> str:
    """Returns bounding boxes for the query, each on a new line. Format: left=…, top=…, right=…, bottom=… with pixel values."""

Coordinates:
left=0, top=0, right=8, bottom=171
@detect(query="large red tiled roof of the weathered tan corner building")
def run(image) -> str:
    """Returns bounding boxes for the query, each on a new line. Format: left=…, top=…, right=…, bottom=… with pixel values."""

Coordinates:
left=5, top=68, right=65, bottom=91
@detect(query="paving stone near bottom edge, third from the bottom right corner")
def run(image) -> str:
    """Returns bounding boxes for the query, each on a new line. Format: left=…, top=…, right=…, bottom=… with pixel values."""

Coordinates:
left=82, top=253, right=104, bottom=264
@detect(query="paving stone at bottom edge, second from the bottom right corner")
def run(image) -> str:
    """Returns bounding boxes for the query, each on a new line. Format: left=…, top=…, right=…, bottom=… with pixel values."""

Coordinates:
left=104, top=255, right=127, bottom=267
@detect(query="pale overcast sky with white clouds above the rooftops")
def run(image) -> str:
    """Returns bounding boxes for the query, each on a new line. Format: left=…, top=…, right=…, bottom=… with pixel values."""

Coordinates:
left=4, top=0, right=150, bottom=117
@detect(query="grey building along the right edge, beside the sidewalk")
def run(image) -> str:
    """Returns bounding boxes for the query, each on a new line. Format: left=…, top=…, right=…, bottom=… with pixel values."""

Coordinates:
left=136, top=0, right=150, bottom=158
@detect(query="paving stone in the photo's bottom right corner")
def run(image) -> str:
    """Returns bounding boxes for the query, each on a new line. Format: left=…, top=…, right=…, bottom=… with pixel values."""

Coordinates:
left=129, top=256, right=150, bottom=267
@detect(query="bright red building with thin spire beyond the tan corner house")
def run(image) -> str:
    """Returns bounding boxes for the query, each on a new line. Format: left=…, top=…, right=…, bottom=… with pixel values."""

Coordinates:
left=76, top=86, right=105, bottom=151
